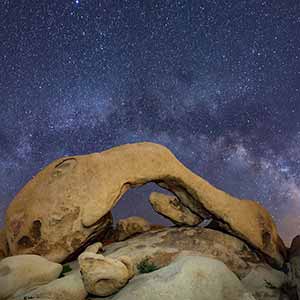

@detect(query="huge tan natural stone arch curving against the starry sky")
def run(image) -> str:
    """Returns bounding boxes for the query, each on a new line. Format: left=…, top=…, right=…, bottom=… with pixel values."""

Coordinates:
left=6, top=143, right=286, bottom=266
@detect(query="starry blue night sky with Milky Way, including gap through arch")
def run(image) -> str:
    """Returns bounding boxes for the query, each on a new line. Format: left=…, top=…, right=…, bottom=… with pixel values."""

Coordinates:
left=0, top=0, right=300, bottom=246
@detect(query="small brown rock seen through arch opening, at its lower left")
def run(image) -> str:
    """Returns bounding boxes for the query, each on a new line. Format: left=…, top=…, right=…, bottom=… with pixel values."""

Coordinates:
left=114, top=216, right=151, bottom=241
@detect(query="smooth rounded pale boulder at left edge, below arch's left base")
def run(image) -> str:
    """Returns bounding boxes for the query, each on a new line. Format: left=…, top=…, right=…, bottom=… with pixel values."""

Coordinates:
left=0, top=255, right=62, bottom=299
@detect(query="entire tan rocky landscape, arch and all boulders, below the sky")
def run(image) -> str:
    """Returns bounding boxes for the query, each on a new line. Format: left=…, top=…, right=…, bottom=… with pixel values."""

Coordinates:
left=0, top=143, right=300, bottom=300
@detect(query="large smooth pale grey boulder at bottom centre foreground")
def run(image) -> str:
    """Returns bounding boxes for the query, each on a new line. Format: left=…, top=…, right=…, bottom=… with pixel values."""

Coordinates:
left=89, top=257, right=255, bottom=300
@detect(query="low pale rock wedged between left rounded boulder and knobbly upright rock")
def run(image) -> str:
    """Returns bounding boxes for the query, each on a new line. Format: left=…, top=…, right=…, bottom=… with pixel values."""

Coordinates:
left=9, top=272, right=87, bottom=300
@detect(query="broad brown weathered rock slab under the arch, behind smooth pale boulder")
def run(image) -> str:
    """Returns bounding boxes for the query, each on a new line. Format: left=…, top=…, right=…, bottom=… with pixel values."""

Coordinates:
left=102, top=227, right=288, bottom=300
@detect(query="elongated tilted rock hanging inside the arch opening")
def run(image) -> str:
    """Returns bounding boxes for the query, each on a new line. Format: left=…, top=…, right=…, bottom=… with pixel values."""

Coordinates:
left=149, top=192, right=202, bottom=225
